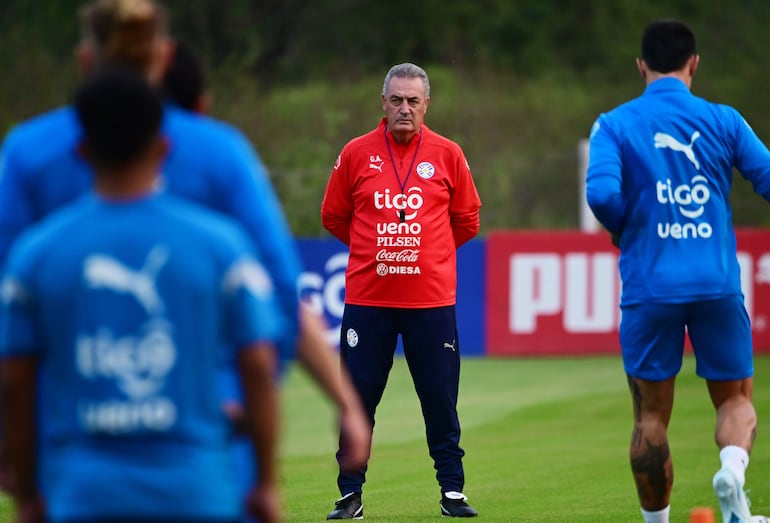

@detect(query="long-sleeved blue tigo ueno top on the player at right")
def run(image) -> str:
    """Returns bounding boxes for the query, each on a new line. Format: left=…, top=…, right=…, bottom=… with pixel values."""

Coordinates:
left=586, top=77, right=770, bottom=305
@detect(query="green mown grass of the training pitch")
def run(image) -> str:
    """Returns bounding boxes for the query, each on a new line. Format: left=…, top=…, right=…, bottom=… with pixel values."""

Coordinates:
left=0, top=356, right=770, bottom=523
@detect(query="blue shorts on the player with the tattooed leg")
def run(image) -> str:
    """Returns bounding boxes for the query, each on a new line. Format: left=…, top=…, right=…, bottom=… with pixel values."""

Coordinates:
left=620, top=296, right=754, bottom=381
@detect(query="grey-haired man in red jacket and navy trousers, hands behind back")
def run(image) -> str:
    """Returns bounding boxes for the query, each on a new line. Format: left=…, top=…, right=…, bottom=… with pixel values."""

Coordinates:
left=321, top=63, right=481, bottom=519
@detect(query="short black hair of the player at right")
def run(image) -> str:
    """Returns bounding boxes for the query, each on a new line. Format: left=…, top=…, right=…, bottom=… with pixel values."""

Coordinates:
left=642, top=20, right=696, bottom=74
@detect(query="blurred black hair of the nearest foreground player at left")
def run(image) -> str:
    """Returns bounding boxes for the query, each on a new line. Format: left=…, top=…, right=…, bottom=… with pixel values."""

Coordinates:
left=74, top=67, right=163, bottom=168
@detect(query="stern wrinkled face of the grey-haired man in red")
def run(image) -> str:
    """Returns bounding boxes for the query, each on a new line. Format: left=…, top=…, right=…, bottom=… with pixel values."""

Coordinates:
left=382, top=77, right=430, bottom=143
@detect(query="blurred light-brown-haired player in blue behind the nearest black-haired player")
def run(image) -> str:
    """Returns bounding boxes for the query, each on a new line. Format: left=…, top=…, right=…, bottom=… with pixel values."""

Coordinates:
left=0, top=0, right=370, bottom=516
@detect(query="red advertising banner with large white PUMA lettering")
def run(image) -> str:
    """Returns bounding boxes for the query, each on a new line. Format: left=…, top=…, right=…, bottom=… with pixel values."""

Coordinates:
left=486, top=229, right=770, bottom=355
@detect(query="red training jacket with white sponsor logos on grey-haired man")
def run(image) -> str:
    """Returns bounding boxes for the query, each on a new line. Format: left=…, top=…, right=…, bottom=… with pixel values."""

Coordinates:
left=321, top=118, right=481, bottom=308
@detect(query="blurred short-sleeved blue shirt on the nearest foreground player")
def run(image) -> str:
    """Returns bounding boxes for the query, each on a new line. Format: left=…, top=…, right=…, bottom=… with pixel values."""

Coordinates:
left=0, top=194, right=284, bottom=521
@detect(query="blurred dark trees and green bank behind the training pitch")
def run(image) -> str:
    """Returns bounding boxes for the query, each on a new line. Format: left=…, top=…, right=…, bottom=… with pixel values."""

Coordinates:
left=0, top=0, right=770, bottom=236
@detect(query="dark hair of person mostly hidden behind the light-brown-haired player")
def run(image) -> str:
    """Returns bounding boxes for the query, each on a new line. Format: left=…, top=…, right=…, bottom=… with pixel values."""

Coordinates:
left=163, top=41, right=207, bottom=111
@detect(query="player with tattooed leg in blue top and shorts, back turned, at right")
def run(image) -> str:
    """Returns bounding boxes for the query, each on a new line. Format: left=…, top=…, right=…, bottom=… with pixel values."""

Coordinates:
left=586, top=20, right=770, bottom=523
